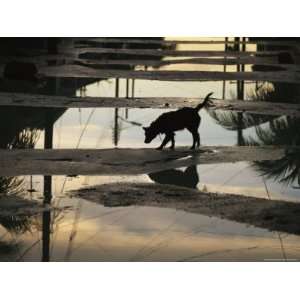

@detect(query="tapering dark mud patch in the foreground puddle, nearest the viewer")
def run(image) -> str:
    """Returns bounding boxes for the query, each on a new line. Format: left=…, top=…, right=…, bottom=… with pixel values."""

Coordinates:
left=71, top=183, right=300, bottom=235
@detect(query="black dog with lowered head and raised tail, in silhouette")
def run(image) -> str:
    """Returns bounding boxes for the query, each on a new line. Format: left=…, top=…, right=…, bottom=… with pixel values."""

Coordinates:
left=143, top=93, right=213, bottom=150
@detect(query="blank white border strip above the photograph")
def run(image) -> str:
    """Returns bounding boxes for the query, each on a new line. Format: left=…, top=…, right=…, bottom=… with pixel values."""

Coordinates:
left=0, top=0, right=300, bottom=36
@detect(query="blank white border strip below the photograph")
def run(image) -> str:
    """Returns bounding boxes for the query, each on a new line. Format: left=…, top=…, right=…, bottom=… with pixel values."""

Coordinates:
left=0, top=263, right=299, bottom=300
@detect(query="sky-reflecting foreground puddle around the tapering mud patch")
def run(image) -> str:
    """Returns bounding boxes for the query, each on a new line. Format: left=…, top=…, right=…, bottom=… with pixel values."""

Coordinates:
left=0, top=163, right=300, bottom=261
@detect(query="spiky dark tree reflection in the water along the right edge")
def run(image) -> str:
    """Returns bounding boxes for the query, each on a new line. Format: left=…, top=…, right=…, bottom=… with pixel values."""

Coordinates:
left=208, top=78, right=300, bottom=186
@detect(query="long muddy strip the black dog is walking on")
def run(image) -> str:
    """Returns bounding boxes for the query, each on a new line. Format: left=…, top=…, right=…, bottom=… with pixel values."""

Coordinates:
left=0, top=146, right=285, bottom=176
